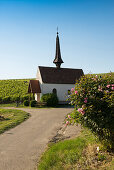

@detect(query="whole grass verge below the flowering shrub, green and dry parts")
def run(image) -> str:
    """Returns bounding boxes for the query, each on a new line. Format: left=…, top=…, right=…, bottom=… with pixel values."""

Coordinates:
left=38, top=129, right=114, bottom=170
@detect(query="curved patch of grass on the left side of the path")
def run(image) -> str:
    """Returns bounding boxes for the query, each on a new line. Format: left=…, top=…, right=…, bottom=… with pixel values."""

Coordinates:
left=0, top=109, right=29, bottom=133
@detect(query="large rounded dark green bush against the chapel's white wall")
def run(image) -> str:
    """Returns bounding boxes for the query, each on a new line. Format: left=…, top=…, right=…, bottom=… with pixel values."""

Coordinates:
left=41, top=93, right=58, bottom=106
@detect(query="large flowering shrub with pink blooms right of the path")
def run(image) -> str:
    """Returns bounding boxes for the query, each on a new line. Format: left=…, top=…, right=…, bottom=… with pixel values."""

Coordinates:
left=67, top=74, right=114, bottom=147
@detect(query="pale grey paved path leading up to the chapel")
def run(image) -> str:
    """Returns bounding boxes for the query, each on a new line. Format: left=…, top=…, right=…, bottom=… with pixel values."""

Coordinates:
left=0, top=108, right=72, bottom=170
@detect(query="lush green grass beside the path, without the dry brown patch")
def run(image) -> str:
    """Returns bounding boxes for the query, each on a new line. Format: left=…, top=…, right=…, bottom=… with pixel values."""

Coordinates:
left=38, top=128, right=95, bottom=170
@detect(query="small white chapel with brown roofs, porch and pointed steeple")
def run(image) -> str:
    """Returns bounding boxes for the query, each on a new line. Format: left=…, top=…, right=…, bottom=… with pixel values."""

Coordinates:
left=28, top=31, right=84, bottom=104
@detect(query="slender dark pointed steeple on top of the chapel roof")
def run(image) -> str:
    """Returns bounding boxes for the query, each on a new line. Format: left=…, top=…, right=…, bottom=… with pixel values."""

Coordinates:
left=53, top=29, right=64, bottom=68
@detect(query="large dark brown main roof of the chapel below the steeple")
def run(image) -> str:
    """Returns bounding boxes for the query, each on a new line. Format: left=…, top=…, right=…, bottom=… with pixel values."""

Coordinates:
left=39, top=66, right=84, bottom=84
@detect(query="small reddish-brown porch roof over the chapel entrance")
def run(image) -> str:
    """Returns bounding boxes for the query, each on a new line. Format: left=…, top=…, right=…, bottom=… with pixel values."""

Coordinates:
left=28, top=80, right=41, bottom=93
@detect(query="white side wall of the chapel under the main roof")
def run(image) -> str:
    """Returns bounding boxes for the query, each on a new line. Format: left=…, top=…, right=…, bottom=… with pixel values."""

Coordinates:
left=40, top=83, right=75, bottom=101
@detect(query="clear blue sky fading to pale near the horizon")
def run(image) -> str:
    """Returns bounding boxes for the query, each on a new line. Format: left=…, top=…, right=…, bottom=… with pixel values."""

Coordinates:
left=0, top=0, right=114, bottom=79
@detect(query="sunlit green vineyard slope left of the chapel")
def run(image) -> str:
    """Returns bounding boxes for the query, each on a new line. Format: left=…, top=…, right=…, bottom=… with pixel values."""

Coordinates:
left=0, top=79, right=34, bottom=103
